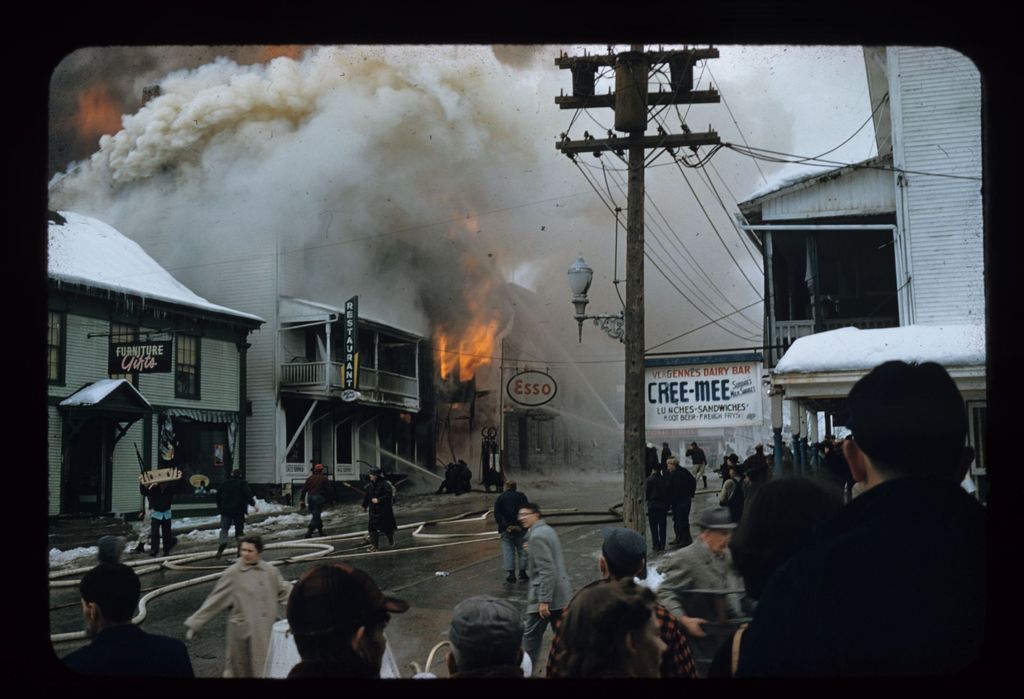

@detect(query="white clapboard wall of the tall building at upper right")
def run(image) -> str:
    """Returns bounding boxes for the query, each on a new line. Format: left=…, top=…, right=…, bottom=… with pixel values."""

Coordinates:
left=888, top=47, right=984, bottom=324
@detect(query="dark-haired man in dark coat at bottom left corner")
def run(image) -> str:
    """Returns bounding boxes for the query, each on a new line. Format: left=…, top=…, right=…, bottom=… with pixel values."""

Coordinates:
left=63, top=563, right=195, bottom=678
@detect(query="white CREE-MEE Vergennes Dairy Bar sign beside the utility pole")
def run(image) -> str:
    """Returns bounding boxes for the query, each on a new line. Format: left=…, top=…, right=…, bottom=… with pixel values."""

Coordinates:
left=644, top=354, right=762, bottom=430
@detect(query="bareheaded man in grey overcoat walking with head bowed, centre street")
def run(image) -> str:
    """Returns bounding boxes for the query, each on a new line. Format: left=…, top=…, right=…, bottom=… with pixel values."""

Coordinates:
left=519, top=503, right=572, bottom=670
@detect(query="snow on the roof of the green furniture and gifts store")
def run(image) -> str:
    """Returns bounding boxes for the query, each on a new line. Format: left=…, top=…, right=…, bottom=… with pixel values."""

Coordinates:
left=48, top=211, right=263, bottom=321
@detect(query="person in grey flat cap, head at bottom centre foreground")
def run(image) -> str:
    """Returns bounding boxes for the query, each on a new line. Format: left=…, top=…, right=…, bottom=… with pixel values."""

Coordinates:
left=446, top=596, right=523, bottom=679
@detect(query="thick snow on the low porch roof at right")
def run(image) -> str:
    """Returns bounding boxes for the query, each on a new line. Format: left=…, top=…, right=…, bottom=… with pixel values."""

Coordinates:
left=774, top=323, right=985, bottom=374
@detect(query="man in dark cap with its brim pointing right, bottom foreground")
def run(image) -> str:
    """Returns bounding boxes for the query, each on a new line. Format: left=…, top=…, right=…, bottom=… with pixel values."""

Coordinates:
left=288, top=563, right=409, bottom=679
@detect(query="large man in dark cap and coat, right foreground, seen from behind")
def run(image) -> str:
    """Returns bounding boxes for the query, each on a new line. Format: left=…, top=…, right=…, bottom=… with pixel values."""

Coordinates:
left=736, top=361, right=986, bottom=676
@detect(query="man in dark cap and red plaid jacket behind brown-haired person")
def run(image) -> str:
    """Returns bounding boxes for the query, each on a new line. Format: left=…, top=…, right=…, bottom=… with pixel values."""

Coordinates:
left=544, top=527, right=697, bottom=679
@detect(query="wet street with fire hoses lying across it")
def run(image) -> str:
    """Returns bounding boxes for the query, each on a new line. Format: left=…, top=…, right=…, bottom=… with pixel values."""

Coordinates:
left=50, top=472, right=718, bottom=678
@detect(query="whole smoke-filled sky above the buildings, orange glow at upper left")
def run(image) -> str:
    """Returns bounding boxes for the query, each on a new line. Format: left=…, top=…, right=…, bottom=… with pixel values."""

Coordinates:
left=48, top=45, right=876, bottom=368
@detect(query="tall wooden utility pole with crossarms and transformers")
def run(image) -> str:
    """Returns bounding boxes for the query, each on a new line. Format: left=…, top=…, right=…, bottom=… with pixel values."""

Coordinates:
left=555, top=44, right=720, bottom=534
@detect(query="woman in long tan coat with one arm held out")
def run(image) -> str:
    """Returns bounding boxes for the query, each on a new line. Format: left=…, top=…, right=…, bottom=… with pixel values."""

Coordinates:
left=185, top=535, right=292, bottom=678
